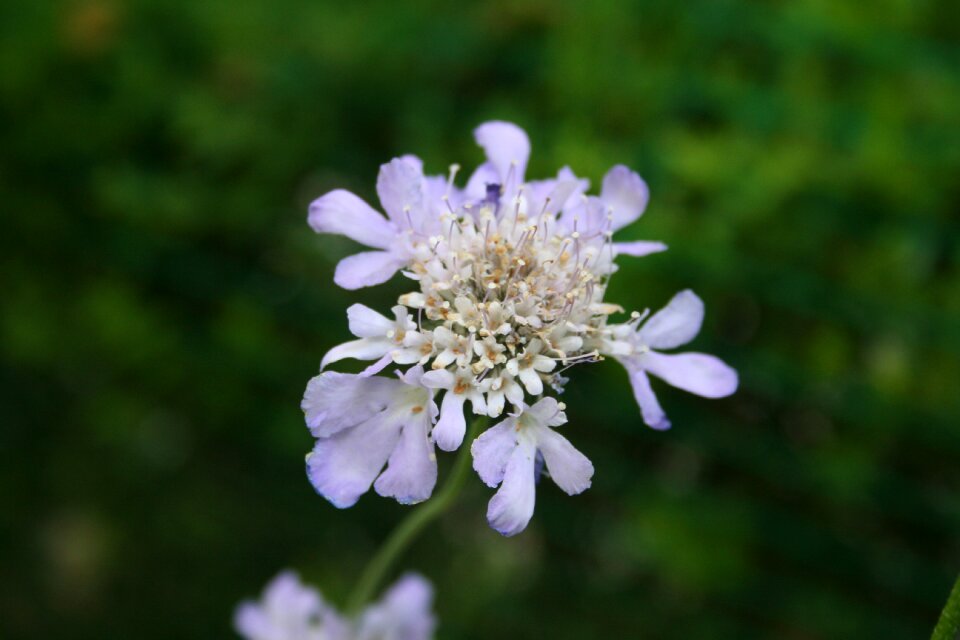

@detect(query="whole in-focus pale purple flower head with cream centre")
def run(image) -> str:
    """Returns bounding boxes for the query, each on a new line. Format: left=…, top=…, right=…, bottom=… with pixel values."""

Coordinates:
left=302, top=122, right=737, bottom=535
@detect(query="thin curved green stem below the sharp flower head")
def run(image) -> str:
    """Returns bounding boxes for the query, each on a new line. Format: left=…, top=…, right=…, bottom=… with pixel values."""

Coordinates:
left=347, top=417, right=486, bottom=614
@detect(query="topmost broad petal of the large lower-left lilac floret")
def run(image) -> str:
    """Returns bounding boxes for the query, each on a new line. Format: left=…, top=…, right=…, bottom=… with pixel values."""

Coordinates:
left=300, top=371, right=399, bottom=438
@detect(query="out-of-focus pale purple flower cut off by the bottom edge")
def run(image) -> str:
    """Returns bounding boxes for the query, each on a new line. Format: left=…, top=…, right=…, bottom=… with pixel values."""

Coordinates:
left=234, top=571, right=436, bottom=640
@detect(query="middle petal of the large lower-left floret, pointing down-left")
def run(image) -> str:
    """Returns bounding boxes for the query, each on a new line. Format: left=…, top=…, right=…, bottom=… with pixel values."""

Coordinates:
left=307, top=410, right=401, bottom=509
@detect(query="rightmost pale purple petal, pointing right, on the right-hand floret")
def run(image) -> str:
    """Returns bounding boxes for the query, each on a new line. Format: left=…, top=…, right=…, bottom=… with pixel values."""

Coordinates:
left=641, top=351, right=738, bottom=398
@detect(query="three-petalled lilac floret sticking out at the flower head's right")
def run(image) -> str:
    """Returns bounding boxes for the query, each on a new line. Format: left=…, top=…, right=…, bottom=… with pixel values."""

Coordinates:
left=605, top=289, right=738, bottom=429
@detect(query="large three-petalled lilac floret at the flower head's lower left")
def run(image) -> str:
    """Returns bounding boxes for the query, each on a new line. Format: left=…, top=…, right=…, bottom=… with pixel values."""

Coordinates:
left=301, top=366, right=437, bottom=509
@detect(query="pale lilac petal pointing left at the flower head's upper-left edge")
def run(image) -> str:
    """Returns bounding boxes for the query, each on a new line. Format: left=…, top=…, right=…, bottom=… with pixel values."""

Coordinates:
left=307, top=189, right=396, bottom=249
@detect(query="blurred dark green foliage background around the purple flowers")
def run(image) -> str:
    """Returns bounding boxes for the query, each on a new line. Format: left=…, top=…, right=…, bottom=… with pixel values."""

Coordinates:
left=0, top=0, right=960, bottom=640
